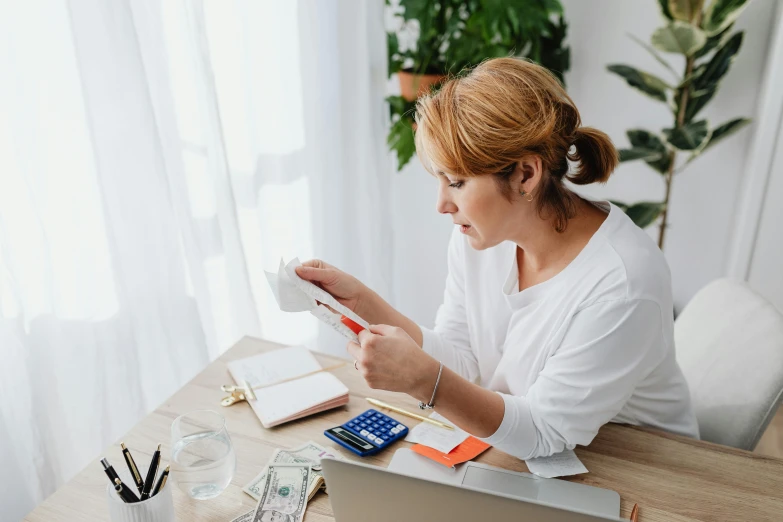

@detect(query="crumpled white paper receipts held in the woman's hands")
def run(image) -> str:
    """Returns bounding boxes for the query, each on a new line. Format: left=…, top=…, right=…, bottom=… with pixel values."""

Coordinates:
left=264, top=258, right=370, bottom=341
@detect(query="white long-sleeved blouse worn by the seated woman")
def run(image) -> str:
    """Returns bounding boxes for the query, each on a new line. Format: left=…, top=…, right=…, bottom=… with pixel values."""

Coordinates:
left=422, top=203, right=699, bottom=459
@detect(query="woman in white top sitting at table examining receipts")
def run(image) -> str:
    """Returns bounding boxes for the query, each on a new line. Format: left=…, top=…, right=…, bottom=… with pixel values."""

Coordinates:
left=297, top=58, right=698, bottom=459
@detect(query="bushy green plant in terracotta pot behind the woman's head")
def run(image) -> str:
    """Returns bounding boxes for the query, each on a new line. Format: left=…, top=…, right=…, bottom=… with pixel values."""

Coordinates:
left=386, top=0, right=570, bottom=170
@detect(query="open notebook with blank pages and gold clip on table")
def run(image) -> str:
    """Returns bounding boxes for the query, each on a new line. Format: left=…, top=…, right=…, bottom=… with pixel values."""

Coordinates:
left=228, top=346, right=348, bottom=428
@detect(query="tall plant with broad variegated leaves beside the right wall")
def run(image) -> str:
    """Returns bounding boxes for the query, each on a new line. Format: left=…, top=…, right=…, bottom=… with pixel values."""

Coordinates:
left=608, top=0, right=750, bottom=249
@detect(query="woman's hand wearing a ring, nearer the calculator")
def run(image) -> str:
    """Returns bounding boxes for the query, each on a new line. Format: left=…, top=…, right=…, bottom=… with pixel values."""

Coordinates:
left=348, top=324, right=438, bottom=397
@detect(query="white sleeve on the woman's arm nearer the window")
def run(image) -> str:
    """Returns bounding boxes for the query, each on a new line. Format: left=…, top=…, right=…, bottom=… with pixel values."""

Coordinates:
left=420, top=231, right=479, bottom=381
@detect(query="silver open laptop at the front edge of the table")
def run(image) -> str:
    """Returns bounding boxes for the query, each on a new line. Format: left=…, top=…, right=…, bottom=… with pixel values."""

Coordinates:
left=321, top=449, right=621, bottom=522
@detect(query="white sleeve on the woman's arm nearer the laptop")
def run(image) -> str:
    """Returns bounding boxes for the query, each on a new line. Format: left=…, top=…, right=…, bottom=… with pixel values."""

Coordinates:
left=484, top=299, right=669, bottom=459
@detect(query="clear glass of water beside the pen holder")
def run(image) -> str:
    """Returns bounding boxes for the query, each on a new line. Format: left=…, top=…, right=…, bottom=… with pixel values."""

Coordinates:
left=171, top=410, right=237, bottom=500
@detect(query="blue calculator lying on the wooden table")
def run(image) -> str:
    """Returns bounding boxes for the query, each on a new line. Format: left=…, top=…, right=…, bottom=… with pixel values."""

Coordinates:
left=324, top=409, right=408, bottom=457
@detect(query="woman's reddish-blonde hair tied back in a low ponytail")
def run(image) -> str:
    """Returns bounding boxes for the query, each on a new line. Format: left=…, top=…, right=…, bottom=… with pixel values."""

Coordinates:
left=416, top=58, right=618, bottom=232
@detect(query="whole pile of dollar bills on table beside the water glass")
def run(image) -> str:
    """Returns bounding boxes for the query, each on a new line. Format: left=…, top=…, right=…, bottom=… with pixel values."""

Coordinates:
left=231, top=441, right=342, bottom=522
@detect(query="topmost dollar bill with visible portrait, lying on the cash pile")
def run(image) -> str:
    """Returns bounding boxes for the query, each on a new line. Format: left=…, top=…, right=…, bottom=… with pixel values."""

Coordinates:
left=250, top=464, right=310, bottom=522
